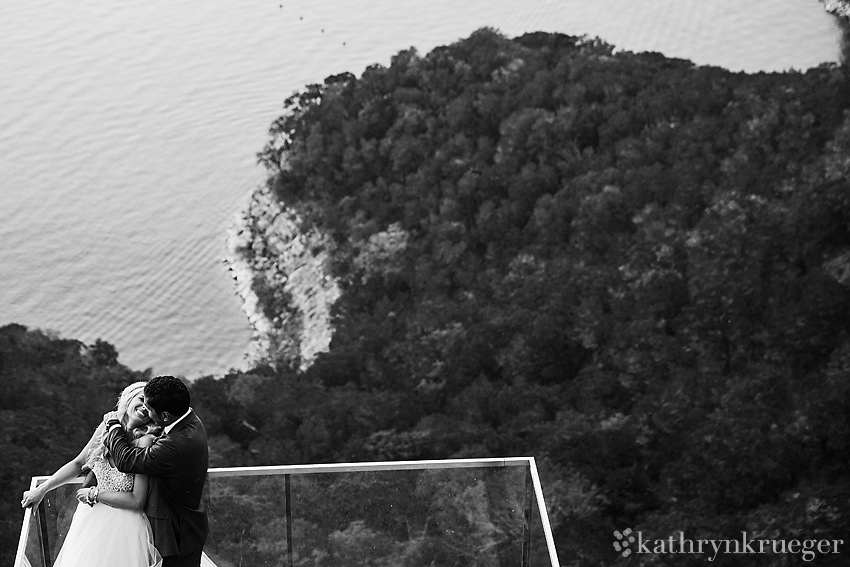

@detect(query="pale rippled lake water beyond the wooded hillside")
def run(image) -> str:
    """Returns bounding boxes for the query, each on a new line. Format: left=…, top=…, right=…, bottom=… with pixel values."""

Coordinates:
left=0, top=0, right=840, bottom=378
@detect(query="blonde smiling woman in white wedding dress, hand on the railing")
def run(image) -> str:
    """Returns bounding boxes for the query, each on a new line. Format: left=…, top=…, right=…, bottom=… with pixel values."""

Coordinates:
left=21, top=382, right=162, bottom=567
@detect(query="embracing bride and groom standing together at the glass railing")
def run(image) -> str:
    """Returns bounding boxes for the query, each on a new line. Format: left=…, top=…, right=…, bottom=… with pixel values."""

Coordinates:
left=21, top=376, right=209, bottom=567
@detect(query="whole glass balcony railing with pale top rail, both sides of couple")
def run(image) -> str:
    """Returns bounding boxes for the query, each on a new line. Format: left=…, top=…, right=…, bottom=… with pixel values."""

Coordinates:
left=16, top=460, right=557, bottom=567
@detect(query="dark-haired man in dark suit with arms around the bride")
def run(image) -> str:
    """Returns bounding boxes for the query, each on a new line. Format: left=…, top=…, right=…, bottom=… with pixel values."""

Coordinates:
left=104, top=376, right=209, bottom=567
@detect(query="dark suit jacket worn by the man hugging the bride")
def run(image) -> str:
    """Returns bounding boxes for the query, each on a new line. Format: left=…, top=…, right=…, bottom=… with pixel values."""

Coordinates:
left=104, top=411, right=209, bottom=557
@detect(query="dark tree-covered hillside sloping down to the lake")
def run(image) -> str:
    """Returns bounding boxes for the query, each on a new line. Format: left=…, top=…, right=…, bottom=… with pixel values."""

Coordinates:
left=9, top=30, right=850, bottom=567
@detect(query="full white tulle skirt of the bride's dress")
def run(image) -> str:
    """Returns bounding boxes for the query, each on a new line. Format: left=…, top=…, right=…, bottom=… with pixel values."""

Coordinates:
left=54, top=502, right=162, bottom=567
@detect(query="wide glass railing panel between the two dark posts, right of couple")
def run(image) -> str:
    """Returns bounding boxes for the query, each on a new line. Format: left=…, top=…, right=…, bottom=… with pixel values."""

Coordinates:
left=292, top=467, right=526, bottom=567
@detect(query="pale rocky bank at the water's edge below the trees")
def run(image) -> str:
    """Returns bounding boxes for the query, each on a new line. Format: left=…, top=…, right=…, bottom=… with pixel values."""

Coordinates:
left=224, top=186, right=340, bottom=369
